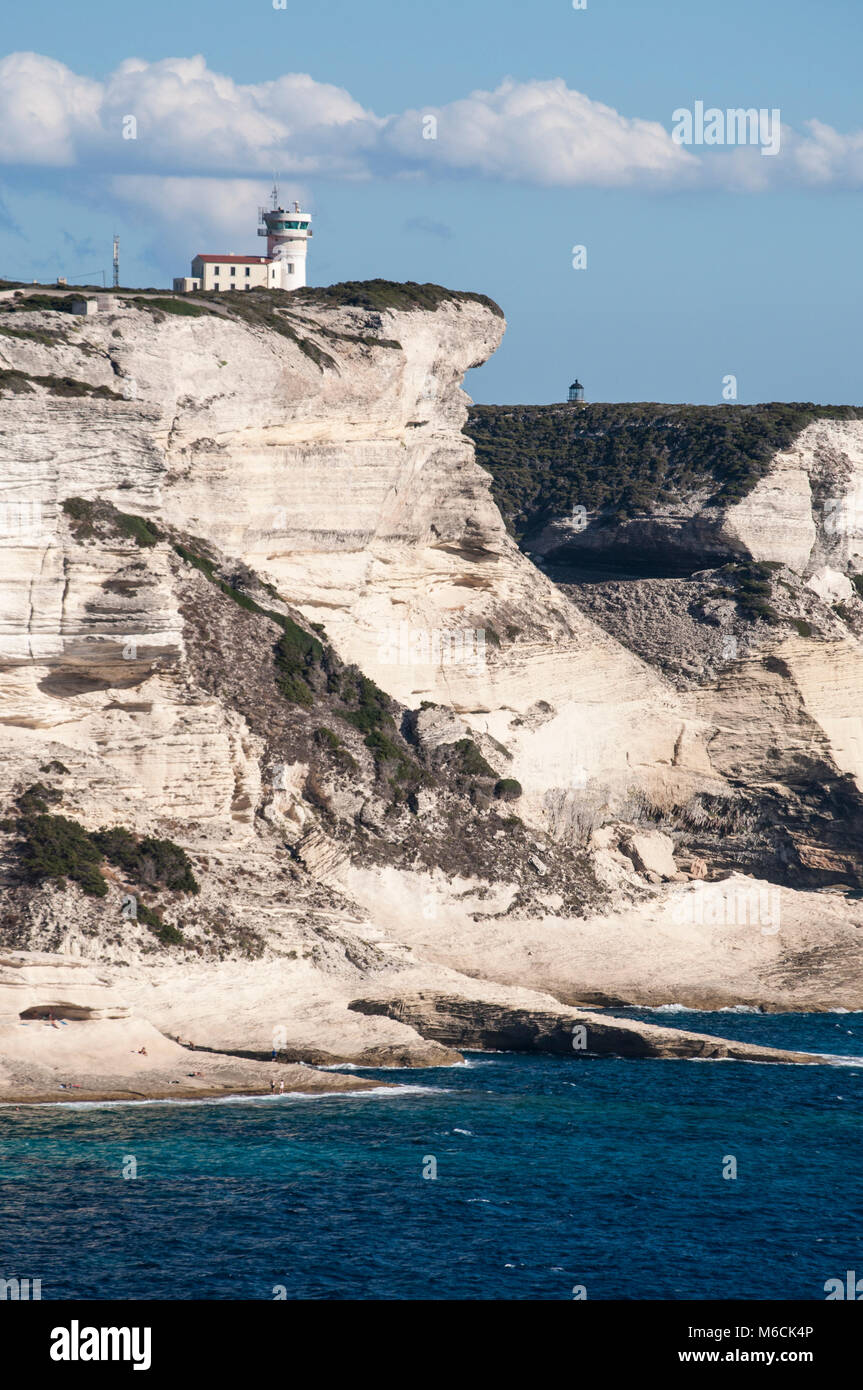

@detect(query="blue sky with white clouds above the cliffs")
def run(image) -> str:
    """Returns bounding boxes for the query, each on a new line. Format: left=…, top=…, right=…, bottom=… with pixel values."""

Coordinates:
left=0, top=0, right=863, bottom=404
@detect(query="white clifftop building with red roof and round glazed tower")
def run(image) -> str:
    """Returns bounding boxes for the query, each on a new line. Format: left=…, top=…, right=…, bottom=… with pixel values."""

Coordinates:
left=174, top=188, right=313, bottom=293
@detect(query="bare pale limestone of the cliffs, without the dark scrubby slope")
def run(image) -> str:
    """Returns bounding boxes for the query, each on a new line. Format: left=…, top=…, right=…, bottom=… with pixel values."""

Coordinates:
left=0, top=282, right=863, bottom=1061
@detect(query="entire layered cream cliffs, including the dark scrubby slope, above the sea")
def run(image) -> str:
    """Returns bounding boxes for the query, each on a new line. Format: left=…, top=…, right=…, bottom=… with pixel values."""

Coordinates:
left=0, top=279, right=863, bottom=1062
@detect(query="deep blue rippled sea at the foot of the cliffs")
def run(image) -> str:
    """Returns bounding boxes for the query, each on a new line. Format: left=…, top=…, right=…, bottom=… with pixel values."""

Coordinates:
left=0, top=1009, right=863, bottom=1300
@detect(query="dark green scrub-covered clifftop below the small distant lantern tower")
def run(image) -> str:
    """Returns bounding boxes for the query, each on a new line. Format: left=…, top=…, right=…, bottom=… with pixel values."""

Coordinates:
left=464, top=402, right=863, bottom=538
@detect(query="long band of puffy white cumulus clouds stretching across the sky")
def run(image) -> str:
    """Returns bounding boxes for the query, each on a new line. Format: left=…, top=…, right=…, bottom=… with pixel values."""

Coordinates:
left=0, top=53, right=863, bottom=194
